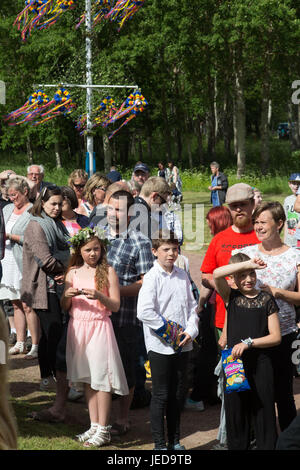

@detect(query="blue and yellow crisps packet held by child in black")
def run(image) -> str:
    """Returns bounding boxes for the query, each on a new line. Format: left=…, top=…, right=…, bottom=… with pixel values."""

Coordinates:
left=222, top=348, right=250, bottom=393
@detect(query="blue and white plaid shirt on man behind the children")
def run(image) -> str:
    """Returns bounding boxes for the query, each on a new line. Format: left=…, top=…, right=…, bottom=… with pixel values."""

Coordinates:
left=105, top=226, right=154, bottom=327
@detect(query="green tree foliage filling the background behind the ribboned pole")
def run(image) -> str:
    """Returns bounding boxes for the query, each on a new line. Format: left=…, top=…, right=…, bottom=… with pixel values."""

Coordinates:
left=0, top=0, right=300, bottom=171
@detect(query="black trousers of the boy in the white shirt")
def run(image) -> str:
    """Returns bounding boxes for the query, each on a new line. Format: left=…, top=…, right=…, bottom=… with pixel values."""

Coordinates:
left=148, top=351, right=189, bottom=449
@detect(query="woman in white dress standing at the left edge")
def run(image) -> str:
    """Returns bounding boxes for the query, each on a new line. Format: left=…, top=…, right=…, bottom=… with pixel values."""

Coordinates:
left=0, top=176, right=39, bottom=359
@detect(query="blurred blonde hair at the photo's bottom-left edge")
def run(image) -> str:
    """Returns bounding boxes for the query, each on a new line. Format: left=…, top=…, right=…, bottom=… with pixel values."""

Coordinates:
left=0, top=308, right=17, bottom=450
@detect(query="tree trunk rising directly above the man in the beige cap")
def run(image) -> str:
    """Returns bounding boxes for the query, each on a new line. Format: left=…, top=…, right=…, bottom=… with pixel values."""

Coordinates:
left=234, top=70, right=246, bottom=179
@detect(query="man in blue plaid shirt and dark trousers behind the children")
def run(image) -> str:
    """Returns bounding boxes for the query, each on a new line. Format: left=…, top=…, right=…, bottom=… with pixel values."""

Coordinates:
left=105, top=190, right=153, bottom=435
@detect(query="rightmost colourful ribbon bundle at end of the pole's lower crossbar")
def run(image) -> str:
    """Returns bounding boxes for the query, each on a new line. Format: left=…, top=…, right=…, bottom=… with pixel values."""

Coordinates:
left=102, top=91, right=148, bottom=139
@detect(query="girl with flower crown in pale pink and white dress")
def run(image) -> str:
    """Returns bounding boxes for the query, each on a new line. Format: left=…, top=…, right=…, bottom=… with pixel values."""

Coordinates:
left=61, top=227, right=128, bottom=447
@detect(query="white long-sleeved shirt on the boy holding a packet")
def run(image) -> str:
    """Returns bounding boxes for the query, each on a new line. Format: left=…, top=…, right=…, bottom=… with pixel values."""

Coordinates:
left=137, top=261, right=199, bottom=354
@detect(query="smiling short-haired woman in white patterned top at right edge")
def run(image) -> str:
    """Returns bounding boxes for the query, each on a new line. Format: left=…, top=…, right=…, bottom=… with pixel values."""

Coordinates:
left=232, top=202, right=300, bottom=431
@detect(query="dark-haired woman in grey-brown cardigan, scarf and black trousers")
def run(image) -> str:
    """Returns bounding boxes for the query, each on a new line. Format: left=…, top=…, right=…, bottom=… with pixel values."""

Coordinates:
left=21, top=186, right=70, bottom=419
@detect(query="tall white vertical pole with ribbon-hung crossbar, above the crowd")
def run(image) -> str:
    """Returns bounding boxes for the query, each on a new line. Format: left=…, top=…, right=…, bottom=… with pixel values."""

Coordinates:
left=85, top=0, right=94, bottom=176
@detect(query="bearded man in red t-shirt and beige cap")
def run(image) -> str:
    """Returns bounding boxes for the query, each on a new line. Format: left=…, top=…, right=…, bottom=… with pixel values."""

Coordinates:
left=200, top=183, right=260, bottom=336
